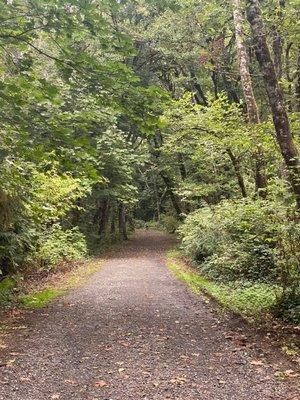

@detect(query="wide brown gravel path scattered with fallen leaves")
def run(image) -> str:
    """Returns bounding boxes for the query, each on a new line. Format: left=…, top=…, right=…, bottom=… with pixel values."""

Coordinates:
left=0, top=231, right=300, bottom=400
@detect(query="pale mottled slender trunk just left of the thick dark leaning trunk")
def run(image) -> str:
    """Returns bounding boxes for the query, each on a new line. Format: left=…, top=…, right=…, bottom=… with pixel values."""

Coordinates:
left=232, top=0, right=267, bottom=198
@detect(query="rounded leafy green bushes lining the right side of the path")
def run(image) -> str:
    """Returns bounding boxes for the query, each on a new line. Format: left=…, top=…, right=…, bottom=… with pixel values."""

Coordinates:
left=178, top=200, right=300, bottom=323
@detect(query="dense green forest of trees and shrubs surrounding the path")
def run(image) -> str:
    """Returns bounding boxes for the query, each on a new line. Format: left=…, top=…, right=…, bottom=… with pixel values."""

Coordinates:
left=0, top=0, right=300, bottom=320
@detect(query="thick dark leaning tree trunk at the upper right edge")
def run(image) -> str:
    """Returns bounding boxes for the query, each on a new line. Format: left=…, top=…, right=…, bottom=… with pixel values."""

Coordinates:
left=247, top=0, right=300, bottom=208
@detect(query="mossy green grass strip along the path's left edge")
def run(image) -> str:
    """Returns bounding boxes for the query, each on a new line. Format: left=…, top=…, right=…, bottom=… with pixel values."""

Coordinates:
left=0, top=259, right=102, bottom=308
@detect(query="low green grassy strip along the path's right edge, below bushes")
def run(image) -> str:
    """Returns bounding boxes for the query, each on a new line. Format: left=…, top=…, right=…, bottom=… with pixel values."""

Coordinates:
left=167, top=250, right=278, bottom=322
